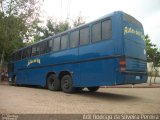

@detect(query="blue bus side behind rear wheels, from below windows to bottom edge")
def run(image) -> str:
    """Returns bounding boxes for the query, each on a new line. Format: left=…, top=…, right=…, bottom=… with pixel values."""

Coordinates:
left=79, top=40, right=116, bottom=87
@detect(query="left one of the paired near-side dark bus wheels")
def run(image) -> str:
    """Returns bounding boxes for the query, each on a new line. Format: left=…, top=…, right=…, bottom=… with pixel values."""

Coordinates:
left=47, top=74, right=60, bottom=91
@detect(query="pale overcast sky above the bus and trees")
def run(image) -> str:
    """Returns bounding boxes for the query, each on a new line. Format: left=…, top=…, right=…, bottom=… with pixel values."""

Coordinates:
left=42, top=0, right=160, bottom=47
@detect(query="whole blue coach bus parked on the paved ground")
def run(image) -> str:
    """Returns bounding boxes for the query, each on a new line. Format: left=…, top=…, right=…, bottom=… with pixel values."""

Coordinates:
left=9, top=11, right=147, bottom=93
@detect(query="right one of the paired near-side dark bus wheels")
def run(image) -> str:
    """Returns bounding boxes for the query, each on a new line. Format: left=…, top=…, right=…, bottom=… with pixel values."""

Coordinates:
left=61, top=75, right=75, bottom=93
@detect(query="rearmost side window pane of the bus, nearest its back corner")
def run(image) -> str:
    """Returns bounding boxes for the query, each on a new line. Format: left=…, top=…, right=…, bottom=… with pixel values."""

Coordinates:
left=102, top=20, right=112, bottom=40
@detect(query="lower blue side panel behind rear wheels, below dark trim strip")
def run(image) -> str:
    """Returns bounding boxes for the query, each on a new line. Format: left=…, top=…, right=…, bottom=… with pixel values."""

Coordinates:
left=80, top=59, right=116, bottom=87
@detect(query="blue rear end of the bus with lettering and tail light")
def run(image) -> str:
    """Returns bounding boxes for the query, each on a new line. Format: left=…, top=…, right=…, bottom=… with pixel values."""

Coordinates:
left=119, top=13, right=147, bottom=84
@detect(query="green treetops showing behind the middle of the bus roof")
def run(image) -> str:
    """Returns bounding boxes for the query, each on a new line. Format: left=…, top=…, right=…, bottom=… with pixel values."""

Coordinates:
left=33, top=16, right=85, bottom=44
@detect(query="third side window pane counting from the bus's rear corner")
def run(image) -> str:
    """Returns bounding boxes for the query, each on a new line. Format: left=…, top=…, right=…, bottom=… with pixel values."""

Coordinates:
left=80, top=27, right=89, bottom=45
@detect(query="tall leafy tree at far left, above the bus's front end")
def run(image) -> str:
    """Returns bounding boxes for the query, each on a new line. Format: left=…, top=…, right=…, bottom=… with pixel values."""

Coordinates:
left=0, top=0, right=40, bottom=64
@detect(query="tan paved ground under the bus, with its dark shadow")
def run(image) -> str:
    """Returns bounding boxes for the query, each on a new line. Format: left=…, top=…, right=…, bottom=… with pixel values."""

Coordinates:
left=0, top=85, right=160, bottom=114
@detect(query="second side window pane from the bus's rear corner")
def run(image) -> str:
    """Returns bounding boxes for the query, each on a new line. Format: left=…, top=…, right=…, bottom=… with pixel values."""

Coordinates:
left=92, top=22, right=101, bottom=42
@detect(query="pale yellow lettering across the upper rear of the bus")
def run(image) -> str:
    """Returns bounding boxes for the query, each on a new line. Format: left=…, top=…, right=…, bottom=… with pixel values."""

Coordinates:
left=124, top=27, right=145, bottom=40
